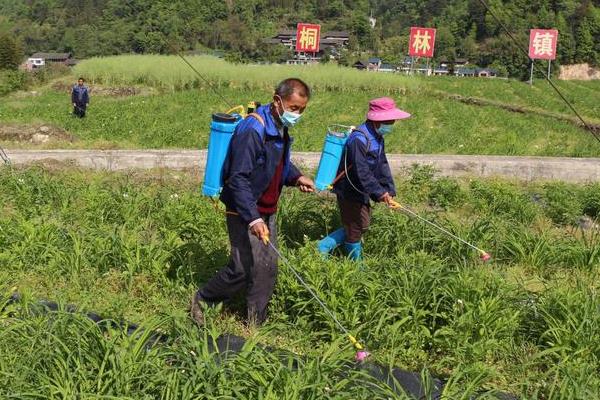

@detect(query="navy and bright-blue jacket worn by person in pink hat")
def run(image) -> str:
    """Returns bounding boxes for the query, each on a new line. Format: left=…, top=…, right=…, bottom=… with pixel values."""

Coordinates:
left=333, top=122, right=396, bottom=204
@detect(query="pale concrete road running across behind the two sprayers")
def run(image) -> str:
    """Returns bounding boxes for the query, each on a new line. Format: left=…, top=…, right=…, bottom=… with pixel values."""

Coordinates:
left=6, top=150, right=600, bottom=182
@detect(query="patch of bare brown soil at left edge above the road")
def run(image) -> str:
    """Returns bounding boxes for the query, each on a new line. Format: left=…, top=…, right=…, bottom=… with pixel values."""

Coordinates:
left=0, top=124, right=77, bottom=144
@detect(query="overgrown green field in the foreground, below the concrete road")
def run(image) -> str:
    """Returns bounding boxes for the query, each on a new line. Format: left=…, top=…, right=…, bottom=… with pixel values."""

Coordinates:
left=0, top=167, right=600, bottom=400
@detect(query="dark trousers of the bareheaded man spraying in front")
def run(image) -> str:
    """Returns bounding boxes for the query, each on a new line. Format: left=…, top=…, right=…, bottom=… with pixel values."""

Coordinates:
left=196, top=214, right=277, bottom=324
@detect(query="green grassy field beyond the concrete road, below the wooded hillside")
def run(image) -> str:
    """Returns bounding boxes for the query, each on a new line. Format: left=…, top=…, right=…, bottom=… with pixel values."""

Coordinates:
left=0, top=56, right=600, bottom=157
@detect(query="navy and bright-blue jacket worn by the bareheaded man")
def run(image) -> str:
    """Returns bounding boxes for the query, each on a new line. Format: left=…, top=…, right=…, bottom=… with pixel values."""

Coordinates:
left=220, top=104, right=302, bottom=223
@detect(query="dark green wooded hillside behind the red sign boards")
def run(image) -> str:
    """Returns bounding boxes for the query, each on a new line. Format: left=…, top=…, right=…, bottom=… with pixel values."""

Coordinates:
left=0, top=0, right=600, bottom=77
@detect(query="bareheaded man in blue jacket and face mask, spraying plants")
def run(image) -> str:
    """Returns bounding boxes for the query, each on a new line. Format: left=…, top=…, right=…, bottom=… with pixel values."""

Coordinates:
left=191, top=78, right=314, bottom=325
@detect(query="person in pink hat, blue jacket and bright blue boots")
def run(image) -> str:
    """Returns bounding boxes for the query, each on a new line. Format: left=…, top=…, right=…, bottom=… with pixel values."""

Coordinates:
left=318, top=97, right=410, bottom=260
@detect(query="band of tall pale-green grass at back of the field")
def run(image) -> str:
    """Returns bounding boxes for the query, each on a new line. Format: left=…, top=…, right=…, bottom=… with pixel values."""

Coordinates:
left=75, top=55, right=417, bottom=94
